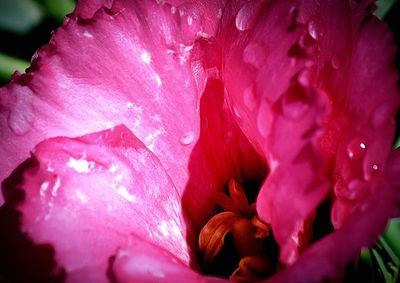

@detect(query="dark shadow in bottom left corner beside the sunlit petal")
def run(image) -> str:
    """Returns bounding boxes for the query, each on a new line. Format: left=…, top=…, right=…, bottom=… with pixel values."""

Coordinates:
left=0, top=158, right=66, bottom=283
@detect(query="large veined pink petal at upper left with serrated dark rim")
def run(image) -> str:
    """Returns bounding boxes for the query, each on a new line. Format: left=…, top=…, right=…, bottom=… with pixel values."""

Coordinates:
left=0, top=0, right=225, bottom=206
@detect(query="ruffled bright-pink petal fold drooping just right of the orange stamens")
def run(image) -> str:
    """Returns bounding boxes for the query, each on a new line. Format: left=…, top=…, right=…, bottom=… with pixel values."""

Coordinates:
left=223, top=1, right=329, bottom=263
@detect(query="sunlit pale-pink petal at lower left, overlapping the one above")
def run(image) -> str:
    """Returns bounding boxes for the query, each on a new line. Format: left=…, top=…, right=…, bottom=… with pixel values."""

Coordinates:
left=15, top=126, right=189, bottom=282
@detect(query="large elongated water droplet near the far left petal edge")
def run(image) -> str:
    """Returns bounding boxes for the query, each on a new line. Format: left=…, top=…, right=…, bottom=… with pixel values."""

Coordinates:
left=8, top=87, right=35, bottom=136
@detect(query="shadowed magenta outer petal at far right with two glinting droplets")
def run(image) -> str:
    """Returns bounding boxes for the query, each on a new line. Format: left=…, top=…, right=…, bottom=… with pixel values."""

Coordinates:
left=324, top=1, right=400, bottom=228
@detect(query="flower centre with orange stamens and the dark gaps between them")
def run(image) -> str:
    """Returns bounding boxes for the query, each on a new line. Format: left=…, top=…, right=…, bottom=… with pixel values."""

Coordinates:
left=199, top=179, right=278, bottom=282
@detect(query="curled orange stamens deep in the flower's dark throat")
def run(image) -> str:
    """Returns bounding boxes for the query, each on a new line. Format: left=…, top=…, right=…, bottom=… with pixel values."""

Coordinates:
left=199, top=179, right=272, bottom=282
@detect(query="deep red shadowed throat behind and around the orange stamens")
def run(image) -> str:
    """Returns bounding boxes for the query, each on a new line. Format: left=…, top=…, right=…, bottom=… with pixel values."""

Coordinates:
left=182, top=76, right=268, bottom=278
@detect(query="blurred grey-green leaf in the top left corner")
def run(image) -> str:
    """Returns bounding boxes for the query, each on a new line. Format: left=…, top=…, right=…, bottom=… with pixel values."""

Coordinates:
left=0, top=0, right=44, bottom=34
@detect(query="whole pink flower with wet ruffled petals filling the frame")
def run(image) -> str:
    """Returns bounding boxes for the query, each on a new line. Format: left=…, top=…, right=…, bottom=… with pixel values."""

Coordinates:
left=0, top=0, right=400, bottom=282
